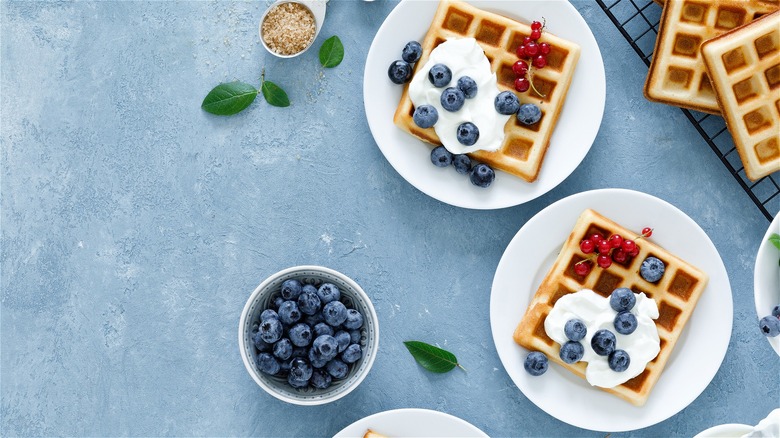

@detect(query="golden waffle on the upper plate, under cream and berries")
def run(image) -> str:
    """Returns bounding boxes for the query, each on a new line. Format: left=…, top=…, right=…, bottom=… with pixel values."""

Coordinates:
left=393, top=0, right=580, bottom=182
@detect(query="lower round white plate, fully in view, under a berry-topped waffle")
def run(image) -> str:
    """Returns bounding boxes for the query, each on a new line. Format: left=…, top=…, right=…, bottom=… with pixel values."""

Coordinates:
left=490, top=189, right=733, bottom=432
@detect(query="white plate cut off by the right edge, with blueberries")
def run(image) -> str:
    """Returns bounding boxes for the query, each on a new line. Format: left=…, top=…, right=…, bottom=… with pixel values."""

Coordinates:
left=753, top=213, right=780, bottom=355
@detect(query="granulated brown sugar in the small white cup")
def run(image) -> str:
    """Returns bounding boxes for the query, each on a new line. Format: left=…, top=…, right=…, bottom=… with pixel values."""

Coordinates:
left=261, top=2, right=315, bottom=55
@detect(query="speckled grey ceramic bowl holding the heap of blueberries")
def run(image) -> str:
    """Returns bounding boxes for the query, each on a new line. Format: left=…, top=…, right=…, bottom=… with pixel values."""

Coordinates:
left=238, top=266, right=379, bottom=405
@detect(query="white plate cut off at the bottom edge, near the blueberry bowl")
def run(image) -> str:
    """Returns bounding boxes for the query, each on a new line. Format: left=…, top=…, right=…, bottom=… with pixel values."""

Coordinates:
left=334, top=409, right=487, bottom=438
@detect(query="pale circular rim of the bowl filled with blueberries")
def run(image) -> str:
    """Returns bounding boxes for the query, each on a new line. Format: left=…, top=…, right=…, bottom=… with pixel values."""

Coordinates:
left=238, top=265, right=379, bottom=406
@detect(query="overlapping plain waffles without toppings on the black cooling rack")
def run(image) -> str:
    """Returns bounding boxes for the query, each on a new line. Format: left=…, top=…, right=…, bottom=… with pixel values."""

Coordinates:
left=644, top=0, right=780, bottom=180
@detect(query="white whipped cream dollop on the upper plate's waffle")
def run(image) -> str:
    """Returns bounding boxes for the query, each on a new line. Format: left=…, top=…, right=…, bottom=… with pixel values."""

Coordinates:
left=409, top=38, right=510, bottom=154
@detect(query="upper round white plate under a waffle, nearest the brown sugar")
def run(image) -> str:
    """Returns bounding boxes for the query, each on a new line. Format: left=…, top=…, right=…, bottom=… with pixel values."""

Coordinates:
left=363, top=0, right=606, bottom=210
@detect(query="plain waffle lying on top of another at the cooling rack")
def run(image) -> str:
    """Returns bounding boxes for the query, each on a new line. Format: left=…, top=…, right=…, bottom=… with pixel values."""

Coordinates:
left=701, top=11, right=780, bottom=181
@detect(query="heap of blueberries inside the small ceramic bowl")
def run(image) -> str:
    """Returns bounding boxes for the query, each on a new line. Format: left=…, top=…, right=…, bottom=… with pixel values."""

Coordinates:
left=252, top=279, right=363, bottom=389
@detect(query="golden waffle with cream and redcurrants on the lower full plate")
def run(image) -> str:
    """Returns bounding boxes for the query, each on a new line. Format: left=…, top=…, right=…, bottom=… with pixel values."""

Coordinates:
left=514, top=209, right=708, bottom=406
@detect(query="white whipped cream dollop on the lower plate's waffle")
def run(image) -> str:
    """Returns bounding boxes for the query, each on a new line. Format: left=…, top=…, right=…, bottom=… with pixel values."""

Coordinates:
left=544, top=289, right=661, bottom=388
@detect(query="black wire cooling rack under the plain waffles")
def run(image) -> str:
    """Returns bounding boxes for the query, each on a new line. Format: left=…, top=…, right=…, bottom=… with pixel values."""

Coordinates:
left=596, top=0, right=780, bottom=221
